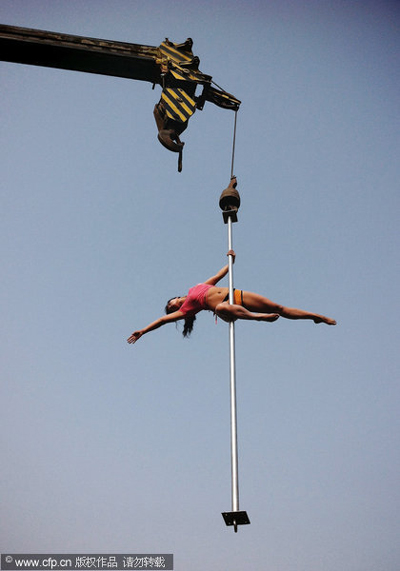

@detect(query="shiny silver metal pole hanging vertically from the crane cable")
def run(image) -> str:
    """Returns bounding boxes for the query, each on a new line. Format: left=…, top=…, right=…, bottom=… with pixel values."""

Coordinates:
left=228, top=216, right=239, bottom=512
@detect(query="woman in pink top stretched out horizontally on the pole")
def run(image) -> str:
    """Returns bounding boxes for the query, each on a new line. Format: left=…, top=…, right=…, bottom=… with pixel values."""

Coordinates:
left=128, top=250, right=336, bottom=343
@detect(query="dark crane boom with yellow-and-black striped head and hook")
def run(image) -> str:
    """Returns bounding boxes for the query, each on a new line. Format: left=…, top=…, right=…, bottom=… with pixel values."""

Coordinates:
left=0, top=24, right=240, bottom=170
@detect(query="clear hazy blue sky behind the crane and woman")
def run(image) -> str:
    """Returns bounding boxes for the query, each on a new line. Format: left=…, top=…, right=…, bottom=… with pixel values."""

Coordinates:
left=0, top=0, right=400, bottom=571
